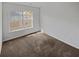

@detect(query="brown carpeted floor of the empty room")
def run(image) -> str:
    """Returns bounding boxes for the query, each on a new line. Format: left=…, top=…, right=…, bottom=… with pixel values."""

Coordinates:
left=0, top=32, right=79, bottom=57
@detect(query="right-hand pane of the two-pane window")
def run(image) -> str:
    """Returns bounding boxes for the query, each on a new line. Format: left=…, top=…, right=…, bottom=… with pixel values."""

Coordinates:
left=23, top=10, right=33, bottom=28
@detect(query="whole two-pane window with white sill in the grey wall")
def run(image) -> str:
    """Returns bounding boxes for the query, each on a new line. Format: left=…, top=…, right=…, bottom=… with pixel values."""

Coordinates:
left=9, top=10, right=33, bottom=31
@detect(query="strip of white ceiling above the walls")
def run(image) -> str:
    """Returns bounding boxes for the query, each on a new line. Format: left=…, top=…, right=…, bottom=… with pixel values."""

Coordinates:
left=16, top=2, right=79, bottom=7
